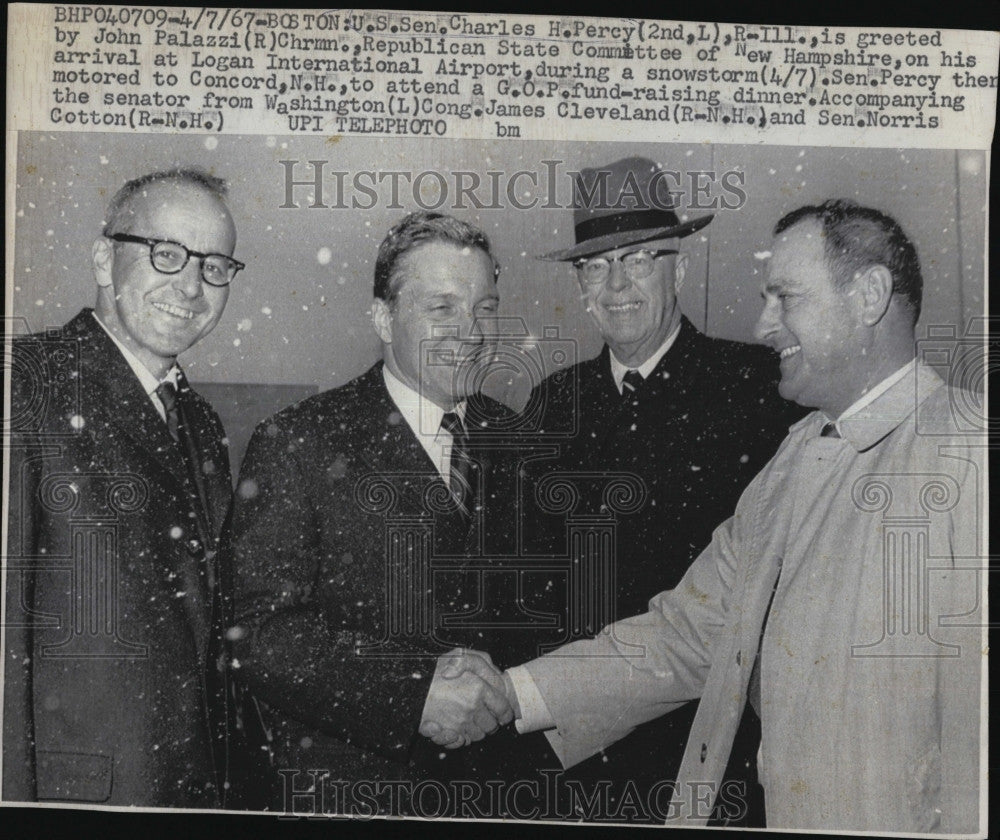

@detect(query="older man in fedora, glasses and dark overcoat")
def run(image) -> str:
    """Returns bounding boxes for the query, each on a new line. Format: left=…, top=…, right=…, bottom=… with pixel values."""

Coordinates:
left=480, top=157, right=801, bottom=822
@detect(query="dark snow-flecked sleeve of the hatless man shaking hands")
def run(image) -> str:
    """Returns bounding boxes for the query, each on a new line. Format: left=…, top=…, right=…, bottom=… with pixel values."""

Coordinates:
left=224, top=422, right=434, bottom=761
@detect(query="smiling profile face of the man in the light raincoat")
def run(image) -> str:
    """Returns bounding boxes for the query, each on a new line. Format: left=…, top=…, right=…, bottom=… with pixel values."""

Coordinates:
left=755, top=219, right=867, bottom=419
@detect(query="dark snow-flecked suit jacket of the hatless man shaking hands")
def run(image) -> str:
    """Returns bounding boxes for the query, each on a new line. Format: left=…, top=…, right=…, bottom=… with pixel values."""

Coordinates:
left=226, top=362, right=509, bottom=814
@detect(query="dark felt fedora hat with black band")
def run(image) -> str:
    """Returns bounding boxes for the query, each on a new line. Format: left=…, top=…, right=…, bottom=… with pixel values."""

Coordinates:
left=538, top=157, right=712, bottom=261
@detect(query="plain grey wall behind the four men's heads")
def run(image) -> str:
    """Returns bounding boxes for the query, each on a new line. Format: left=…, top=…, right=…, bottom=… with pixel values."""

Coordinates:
left=8, top=133, right=987, bottom=404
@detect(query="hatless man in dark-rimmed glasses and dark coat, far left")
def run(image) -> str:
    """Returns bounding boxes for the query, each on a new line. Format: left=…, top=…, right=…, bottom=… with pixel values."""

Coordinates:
left=3, top=169, right=258, bottom=808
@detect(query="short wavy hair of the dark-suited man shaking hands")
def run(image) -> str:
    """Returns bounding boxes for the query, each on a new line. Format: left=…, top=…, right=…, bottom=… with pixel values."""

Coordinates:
left=374, top=210, right=500, bottom=303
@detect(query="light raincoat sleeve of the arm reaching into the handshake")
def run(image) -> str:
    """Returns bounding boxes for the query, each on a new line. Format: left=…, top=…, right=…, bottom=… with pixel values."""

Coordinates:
left=526, top=472, right=759, bottom=756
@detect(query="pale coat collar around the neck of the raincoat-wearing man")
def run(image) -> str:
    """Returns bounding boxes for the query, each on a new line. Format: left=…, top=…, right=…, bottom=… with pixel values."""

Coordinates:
left=816, top=359, right=944, bottom=452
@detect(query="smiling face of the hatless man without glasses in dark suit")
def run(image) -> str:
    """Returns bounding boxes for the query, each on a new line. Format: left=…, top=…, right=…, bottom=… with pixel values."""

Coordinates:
left=372, top=241, right=500, bottom=410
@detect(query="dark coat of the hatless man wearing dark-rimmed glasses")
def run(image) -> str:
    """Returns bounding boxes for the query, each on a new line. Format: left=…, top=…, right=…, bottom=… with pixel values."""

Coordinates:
left=3, top=310, right=238, bottom=807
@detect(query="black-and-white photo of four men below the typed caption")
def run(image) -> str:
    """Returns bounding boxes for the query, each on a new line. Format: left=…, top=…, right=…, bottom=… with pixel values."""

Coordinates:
left=0, top=7, right=996, bottom=837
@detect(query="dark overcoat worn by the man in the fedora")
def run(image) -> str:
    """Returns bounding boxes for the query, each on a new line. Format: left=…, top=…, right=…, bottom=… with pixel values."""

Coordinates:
left=478, top=318, right=803, bottom=821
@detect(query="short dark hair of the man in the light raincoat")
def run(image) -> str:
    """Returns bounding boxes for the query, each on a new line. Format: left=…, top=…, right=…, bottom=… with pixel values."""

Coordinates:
left=774, top=198, right=924, bottom=323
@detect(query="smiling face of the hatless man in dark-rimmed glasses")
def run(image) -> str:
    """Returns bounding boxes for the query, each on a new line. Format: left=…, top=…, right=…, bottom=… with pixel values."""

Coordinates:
left=93, top=180, right=236, bottom=377
